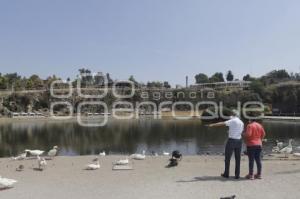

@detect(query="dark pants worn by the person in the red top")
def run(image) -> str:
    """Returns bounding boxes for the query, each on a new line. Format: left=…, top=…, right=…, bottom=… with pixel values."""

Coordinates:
left=247, top=146, right=262, bottom=175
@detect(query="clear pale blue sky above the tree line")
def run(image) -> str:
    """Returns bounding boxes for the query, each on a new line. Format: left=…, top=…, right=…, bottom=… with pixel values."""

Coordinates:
left=0, top=0, right=300, bottom=85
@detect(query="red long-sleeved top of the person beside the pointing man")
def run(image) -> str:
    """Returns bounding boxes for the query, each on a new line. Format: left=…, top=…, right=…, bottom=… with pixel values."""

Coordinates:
left=245, top=122, right=266, bottom=146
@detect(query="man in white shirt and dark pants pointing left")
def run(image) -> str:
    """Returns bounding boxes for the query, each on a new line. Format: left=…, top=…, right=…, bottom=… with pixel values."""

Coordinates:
left=208, top=110, right=244, bottom=179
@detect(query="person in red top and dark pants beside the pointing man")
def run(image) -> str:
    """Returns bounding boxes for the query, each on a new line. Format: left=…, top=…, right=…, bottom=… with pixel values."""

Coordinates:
left=244, top=120, right=266, bottom=180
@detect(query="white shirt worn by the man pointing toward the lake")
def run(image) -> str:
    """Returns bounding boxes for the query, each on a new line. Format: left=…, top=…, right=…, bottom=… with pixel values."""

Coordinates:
left=225, top=116, right=244, bottom=139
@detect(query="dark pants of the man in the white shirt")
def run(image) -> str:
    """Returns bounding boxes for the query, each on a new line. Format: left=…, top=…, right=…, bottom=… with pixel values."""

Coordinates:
left=224, top=138, right=242, bottom=177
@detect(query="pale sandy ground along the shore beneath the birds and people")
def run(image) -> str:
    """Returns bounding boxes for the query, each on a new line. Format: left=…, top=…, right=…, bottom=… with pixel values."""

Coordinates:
left=0, top=156, right=300, bottom=199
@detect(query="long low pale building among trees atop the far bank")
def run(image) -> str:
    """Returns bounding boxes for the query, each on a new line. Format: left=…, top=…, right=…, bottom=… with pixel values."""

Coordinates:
left=190, top=81, right=251, bottom=91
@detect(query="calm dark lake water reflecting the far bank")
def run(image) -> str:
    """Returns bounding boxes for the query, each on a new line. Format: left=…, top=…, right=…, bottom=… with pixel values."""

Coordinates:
left=0, top=119, right=300, bottom=157
